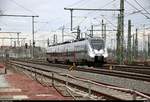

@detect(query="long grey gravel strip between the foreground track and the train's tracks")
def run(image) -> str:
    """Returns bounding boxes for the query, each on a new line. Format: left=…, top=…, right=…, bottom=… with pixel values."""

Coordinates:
left=14, top=63, right=150, bottom=94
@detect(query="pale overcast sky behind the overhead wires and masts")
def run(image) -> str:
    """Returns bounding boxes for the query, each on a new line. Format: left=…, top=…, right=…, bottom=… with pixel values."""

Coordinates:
left=0, top=0, right=150, bottom=47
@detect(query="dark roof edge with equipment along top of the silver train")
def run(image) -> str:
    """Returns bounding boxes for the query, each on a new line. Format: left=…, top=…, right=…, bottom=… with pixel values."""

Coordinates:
left=49, top=37, right=102, bottom=47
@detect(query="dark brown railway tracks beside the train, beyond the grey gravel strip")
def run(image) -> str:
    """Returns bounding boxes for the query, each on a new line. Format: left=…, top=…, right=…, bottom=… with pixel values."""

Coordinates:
left=10, top=60, right=150, bottom=82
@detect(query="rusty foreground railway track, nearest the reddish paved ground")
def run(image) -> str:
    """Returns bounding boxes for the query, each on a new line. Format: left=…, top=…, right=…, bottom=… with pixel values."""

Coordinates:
left=6, top=61, right=150, bottom=100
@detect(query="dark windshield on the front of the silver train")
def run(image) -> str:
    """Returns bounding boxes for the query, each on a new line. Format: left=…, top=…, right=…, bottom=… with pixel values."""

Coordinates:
left=91, top=39, right=104, bottom=50
